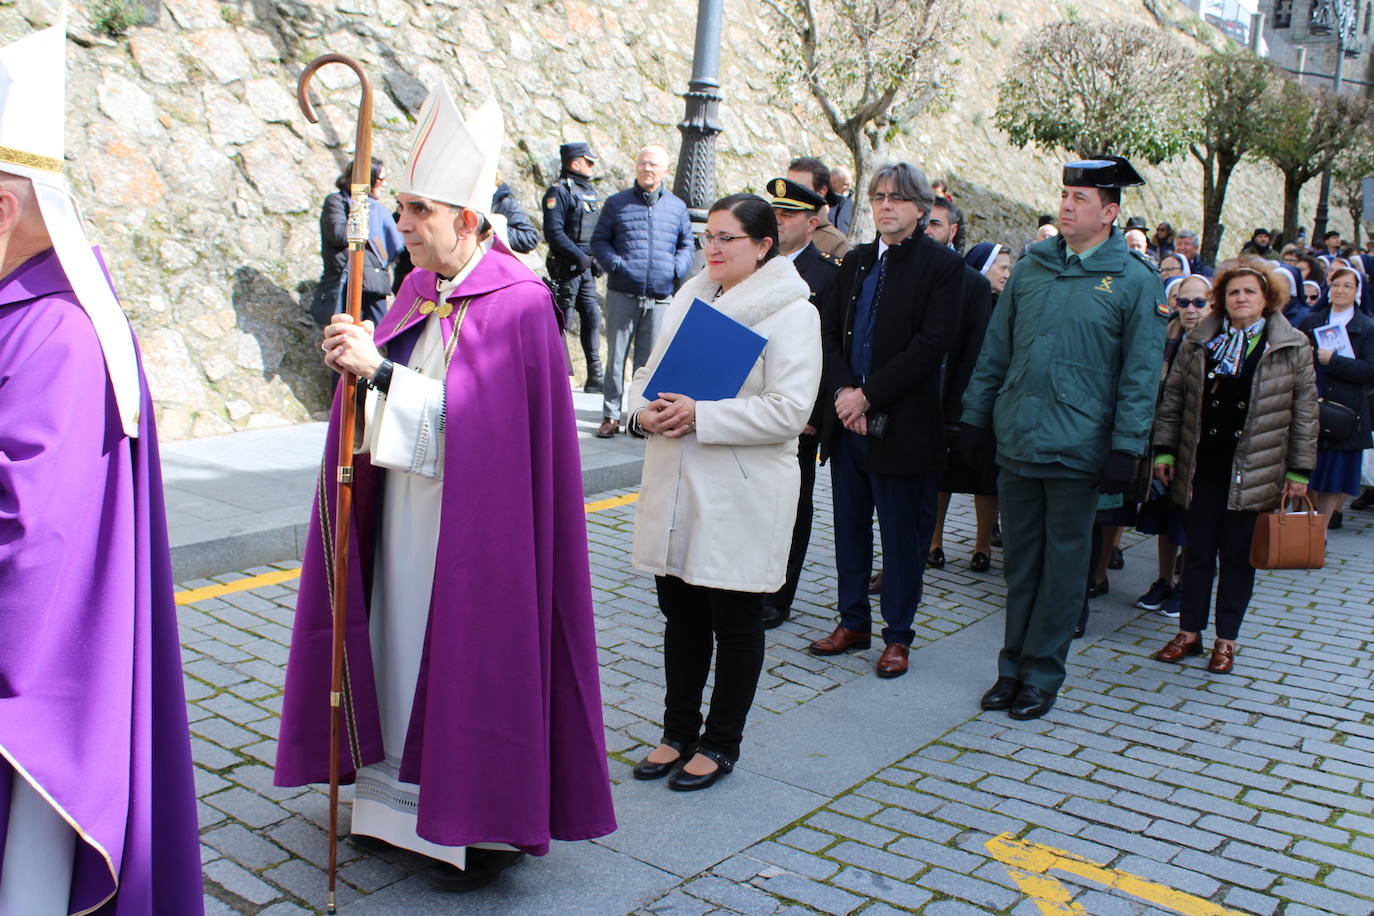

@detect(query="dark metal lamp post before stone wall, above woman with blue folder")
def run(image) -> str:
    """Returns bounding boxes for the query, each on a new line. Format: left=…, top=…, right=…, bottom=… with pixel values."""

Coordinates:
left=673, top=0, right=723, bottom=222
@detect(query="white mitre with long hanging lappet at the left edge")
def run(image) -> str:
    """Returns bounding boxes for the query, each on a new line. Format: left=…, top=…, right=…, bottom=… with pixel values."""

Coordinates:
left=0, top=18, right=140, bottom=437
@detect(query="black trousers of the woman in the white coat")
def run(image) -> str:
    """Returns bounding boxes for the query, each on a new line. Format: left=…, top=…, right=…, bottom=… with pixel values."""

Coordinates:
left=654, top=575, right=764, bottom=761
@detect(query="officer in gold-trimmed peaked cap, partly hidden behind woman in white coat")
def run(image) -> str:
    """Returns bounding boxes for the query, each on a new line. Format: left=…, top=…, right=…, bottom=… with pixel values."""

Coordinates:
left=764, top=179, right=840, bottom=629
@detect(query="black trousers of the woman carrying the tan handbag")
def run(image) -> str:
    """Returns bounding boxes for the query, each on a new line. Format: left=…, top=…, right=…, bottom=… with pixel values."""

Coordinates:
left=1179, top=463, right=1257, bottom=640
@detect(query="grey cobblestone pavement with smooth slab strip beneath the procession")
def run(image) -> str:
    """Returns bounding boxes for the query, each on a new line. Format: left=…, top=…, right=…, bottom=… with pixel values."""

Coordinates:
left=180, top=474, right=1374, bottom=916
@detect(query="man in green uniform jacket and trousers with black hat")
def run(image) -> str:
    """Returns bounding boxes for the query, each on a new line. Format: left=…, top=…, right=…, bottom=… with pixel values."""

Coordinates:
left=959, top=157, right=1168, bottom=720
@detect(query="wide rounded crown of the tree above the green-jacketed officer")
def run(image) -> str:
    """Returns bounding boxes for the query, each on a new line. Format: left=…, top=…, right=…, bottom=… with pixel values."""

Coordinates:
left=995, top=19, right=1197, bottom=163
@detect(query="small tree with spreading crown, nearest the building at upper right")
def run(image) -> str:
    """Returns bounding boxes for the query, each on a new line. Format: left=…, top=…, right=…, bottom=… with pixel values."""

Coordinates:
left=1260, top=78, right=1370, bottom=242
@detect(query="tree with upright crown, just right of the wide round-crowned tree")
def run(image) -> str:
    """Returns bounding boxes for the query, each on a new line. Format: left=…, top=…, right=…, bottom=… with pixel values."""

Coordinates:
left=1189, top=51, right=1279, bottom=264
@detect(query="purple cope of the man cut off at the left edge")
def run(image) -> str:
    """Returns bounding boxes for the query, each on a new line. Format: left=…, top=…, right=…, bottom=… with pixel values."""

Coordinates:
left=0, top=250, right=203, bottom=916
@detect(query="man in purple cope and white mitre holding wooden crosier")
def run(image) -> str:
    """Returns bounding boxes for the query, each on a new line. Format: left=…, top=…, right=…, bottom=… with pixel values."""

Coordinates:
left=276, top=87, right=616, bottom=890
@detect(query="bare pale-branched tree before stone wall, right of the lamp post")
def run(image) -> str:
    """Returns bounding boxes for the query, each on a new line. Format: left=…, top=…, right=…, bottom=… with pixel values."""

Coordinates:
left=763, top=0, right=958, bottom=239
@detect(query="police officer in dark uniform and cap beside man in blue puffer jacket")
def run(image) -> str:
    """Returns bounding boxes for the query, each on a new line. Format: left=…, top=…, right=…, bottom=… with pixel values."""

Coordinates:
left=544, top=143, right=602, bottom=391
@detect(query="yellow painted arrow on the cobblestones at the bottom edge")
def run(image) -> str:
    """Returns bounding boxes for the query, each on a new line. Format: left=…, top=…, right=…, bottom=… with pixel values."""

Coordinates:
left=985, top=834, right=1245, bottom=916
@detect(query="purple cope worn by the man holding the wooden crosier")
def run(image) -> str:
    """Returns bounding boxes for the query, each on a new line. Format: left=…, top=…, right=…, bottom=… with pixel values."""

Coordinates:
left=276, top=242, right=616, bottom=856
